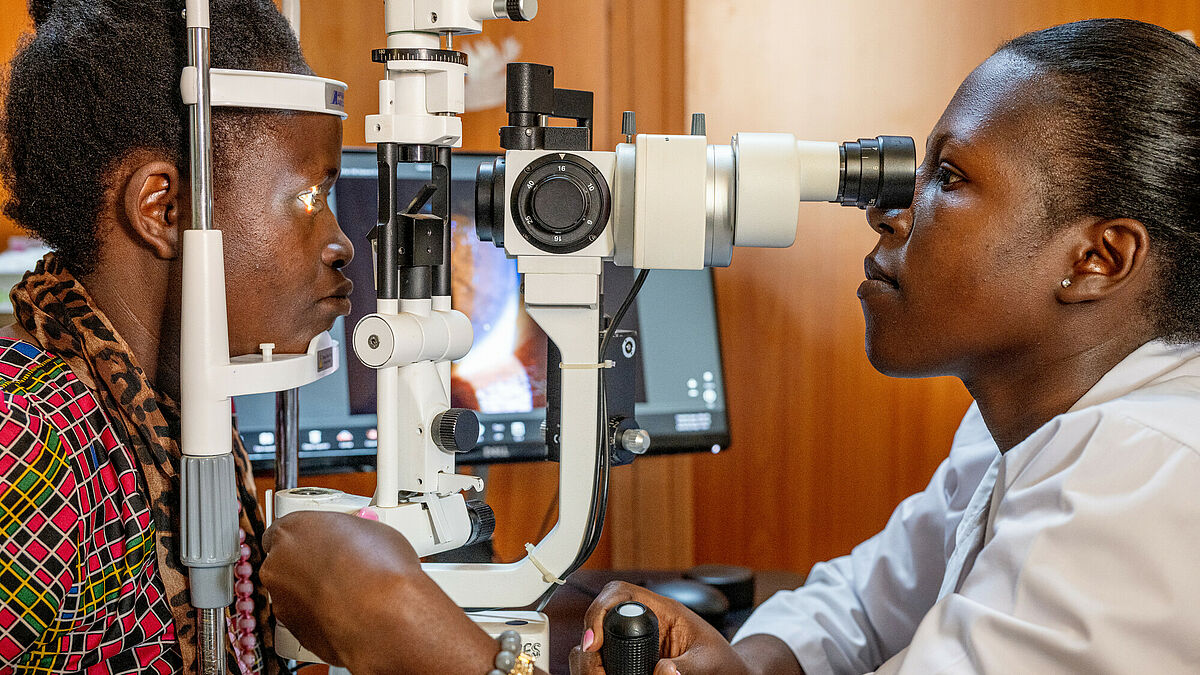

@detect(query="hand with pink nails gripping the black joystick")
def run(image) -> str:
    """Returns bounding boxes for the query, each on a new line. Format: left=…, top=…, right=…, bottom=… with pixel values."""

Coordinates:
left=571, top=581, right=752, bottom=675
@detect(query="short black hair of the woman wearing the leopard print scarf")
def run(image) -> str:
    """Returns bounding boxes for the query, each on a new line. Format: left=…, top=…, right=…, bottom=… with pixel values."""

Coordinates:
left=0, top=0, right=312, bottom=275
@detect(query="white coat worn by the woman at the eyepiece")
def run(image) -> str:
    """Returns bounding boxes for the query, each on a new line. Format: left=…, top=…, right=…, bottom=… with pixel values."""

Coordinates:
left=734, top=341, right=1200, bottom=675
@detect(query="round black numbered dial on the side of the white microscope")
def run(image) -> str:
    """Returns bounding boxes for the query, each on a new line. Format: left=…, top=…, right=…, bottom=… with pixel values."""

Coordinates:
left=512, top=153, right=612, bottom=253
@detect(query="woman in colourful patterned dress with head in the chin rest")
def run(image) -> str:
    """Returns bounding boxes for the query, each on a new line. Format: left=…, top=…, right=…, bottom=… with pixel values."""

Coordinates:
left=0, top=0, right=353, bottom=674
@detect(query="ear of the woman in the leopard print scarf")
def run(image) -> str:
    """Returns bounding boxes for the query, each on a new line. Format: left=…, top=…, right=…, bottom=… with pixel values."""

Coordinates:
left=125, top=160, right=182, bottom=259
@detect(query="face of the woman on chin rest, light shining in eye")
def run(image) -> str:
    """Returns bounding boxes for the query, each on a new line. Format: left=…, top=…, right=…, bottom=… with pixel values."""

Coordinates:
left=214, top=114, right=354, bottom=354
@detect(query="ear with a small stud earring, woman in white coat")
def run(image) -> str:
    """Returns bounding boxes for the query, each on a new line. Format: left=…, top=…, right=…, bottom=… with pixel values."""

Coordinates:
left=1056, top=219, right=1150, bottom=304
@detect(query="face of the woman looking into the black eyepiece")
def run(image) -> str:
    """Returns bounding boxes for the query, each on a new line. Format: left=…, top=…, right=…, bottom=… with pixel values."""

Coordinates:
left=859, top=54, right=1069, bottom=381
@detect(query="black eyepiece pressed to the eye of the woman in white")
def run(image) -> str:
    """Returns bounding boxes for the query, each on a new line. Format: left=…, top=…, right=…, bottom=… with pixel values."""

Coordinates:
left=834, top=136, right=917, bottom=209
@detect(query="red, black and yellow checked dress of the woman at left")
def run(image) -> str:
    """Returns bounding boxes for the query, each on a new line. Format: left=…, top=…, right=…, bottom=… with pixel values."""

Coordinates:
left=0, top=339, right=182, bottom=675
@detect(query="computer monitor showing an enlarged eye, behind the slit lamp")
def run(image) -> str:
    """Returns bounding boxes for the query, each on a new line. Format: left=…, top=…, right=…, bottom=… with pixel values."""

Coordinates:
left=234, top=149, right=730, bottom=472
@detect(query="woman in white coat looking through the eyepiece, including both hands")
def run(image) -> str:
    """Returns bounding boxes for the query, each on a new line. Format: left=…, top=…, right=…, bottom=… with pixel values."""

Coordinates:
left=263, top=14, right=1200, bottom=675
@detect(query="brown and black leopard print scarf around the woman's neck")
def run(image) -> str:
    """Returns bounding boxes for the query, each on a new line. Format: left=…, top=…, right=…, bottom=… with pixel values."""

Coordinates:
left=12, top=253, right=280, bottom=674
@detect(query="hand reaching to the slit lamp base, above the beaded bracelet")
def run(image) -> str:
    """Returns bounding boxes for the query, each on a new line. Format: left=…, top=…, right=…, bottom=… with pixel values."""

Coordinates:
left=260, top=512, right=498, bottom=675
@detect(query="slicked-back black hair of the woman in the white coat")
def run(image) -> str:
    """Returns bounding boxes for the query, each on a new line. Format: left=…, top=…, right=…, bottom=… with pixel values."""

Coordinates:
left=997, top=19, right=1200, bottom=341
